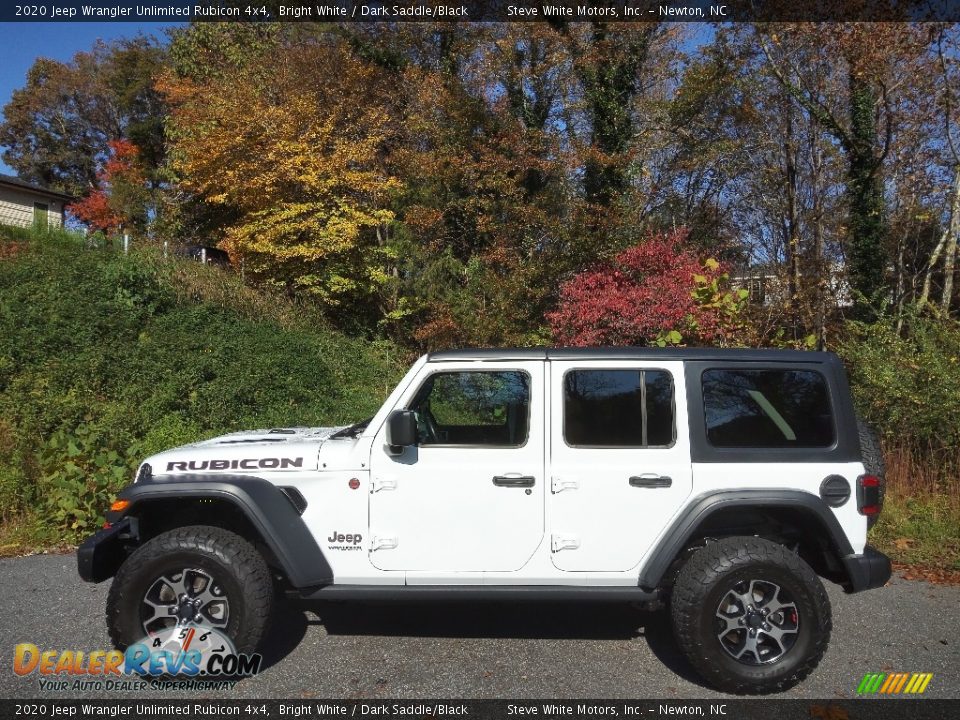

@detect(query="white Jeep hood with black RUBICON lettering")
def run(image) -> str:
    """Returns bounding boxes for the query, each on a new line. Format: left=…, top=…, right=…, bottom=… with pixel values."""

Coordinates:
left=144, top=426, right=345, bottom=475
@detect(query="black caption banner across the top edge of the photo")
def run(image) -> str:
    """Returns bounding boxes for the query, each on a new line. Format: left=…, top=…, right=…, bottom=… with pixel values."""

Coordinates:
left=0, top=0, right=960, bottom=23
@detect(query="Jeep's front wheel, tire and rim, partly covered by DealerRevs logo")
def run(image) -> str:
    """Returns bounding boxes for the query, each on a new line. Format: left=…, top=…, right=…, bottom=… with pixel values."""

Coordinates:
left=107, top=525, right=273, bottom=653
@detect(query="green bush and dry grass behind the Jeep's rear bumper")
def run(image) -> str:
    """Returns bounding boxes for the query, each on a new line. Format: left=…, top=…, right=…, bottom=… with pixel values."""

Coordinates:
left=838, top=314, right=960, bottom=570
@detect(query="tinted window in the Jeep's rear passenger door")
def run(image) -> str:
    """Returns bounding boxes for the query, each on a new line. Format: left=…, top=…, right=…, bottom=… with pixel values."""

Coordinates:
left=563, top=370, right=674, bottom=448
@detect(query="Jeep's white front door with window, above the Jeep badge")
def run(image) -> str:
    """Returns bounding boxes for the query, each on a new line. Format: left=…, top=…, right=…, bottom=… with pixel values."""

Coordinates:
left=370, top=361, right=545, bottom=574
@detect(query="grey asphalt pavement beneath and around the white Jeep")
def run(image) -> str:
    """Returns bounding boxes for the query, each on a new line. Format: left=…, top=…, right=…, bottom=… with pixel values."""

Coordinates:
left=0, top=555, right=960, bottom=699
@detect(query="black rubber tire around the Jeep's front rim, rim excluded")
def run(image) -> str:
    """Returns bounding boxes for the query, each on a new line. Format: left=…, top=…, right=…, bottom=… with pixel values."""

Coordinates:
left=107, top=525, right=274, bottom=653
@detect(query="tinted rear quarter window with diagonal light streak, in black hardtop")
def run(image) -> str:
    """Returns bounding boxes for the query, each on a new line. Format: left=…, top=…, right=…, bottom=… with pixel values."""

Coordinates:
left=702, top=369, right=835, bottom=448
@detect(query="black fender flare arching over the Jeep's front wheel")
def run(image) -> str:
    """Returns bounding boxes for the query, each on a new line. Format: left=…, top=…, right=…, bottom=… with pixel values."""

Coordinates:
left=87, top=474, right=333, bottom=588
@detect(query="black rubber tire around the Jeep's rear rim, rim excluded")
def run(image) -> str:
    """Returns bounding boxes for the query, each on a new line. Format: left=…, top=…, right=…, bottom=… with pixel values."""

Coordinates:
left=670, top=537, right=832, bottom=694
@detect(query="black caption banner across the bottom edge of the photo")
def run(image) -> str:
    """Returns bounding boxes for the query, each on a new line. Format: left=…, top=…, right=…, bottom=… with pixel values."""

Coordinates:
left=0, top=698, right=960, bottom=720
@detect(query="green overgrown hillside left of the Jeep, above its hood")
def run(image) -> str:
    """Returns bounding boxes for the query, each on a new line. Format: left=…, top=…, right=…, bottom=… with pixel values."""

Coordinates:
left=0, top=229, right=408, bottom=553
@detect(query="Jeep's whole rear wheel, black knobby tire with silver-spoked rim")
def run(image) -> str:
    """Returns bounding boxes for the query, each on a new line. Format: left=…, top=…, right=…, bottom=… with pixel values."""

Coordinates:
left=671, top=537, right=832, bottom=694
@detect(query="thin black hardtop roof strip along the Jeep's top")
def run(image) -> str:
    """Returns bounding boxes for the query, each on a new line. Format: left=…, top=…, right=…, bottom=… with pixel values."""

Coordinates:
left=427, top=347, right=839, bottom=363
